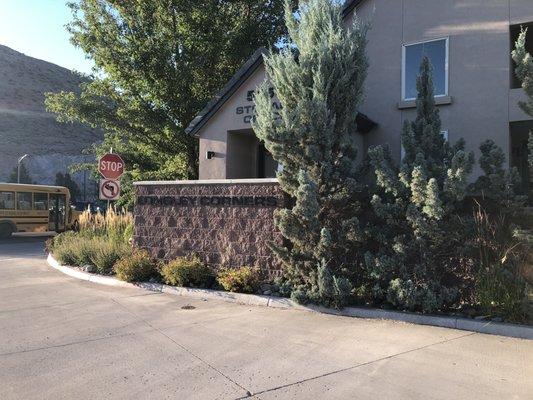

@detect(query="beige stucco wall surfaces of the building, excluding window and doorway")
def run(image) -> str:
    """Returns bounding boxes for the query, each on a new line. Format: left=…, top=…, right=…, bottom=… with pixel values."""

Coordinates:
left=200, top=0, right=533, bottom=179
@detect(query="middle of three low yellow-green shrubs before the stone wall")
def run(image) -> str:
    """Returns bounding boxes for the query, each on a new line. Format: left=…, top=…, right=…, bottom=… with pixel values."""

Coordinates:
left=161, top=257, right=214, bottom=288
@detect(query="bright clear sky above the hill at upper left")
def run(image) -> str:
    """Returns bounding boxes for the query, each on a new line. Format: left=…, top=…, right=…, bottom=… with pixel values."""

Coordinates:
left=0, top=0, right=92, bottom=73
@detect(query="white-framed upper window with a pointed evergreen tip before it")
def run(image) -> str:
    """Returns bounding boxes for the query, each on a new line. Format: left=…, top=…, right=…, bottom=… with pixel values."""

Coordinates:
left=402, top=38, right=448, bottom=100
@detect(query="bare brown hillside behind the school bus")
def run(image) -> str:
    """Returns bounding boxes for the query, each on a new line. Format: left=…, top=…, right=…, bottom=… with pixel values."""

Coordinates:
left=0, top=45, right=102, bottom=188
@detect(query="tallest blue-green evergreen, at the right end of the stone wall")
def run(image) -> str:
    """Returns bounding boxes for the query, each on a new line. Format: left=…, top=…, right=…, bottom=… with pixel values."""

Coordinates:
left=253, top=0, right=368, bottom=307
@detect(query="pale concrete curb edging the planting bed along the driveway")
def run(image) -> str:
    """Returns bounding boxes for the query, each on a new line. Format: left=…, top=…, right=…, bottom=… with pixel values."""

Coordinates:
left=46, top=254, right=533, bottom=340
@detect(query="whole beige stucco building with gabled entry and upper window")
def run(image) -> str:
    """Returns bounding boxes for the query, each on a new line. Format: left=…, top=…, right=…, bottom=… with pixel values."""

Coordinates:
left=188, top=0, right=533, bottom=189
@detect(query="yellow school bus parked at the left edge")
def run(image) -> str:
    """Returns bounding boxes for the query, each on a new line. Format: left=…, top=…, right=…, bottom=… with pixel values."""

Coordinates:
left=0, top=183, right=80, bottom=238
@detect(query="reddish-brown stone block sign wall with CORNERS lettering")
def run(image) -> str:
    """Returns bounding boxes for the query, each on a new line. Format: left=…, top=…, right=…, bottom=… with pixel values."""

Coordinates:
left=134, top=180, right=285, bottom=278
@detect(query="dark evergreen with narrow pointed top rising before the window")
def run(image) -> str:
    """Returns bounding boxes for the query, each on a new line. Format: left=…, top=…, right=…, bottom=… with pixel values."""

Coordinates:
left=365, top=58, right=474, bottom=312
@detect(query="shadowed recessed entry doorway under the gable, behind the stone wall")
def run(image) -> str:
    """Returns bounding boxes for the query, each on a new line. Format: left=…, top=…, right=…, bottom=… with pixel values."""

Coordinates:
left=226, top=129, right=278, bottom=179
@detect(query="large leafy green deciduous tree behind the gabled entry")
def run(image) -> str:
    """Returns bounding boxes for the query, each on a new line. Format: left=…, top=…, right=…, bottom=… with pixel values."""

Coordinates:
left=46, top=0, right=284, bottom=191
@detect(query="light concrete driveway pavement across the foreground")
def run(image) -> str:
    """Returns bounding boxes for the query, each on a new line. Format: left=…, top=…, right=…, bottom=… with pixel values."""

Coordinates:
left=0, top=238, right=533, bottom=400
